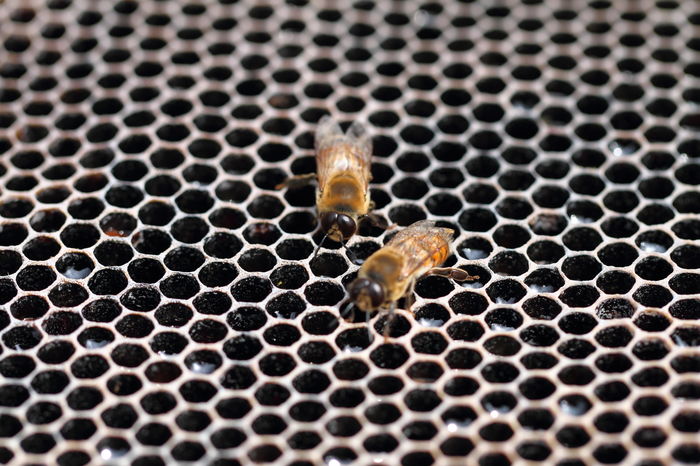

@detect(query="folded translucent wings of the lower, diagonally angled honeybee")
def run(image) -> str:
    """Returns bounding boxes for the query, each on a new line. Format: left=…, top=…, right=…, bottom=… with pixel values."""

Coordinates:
left=386, top=220, right=454, bottom=280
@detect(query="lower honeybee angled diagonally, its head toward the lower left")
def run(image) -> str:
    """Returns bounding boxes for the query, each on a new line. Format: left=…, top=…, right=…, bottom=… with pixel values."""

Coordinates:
left=347, top=220, right=479, bottom=336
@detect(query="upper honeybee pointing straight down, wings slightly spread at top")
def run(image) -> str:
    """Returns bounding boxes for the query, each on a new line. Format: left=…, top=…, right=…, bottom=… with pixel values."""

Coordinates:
left=279, top=116, right=372, bottom=247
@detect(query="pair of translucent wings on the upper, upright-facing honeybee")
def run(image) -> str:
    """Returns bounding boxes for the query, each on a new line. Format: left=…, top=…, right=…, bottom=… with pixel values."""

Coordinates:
left=316, top=116, right=372, bottom=192
